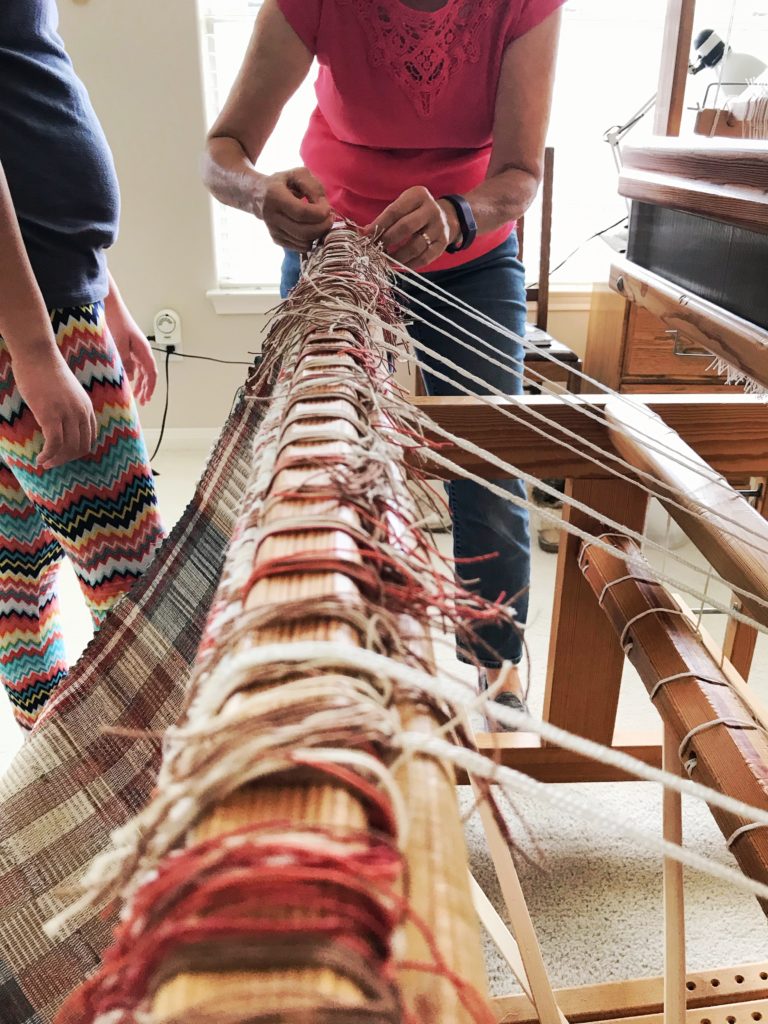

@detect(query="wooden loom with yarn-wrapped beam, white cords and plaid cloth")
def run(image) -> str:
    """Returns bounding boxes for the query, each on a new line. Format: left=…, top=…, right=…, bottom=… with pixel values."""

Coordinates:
left=0, top=209, right=768, bottom=1024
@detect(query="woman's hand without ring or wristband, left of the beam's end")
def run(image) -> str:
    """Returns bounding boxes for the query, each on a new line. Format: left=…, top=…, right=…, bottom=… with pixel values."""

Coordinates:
left=256, top=167, right=333, bottom=253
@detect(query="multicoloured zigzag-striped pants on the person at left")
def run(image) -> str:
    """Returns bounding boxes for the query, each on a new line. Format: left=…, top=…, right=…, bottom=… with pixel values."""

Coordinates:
left=0, top=303, right=165, bottom=729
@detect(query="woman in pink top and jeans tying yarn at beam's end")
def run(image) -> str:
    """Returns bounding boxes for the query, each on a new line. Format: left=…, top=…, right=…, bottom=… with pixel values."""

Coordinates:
left=205, top=0, right=564, bottom=724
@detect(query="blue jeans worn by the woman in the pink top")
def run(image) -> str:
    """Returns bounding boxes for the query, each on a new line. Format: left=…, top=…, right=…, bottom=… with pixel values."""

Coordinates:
left=281, top=232, right=530, bottom=668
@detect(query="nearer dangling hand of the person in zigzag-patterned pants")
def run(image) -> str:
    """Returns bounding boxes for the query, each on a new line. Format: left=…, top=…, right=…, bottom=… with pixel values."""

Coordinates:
left=11, top=342, right=97, bottom=469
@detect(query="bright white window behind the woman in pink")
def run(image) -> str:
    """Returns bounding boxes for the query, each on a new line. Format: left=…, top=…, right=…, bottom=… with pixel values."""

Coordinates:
left=203, top=0, right=768, bottom=288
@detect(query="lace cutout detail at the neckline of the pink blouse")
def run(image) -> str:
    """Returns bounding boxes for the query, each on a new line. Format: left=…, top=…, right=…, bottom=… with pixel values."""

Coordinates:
left=337, top=0, right=499, bottom=118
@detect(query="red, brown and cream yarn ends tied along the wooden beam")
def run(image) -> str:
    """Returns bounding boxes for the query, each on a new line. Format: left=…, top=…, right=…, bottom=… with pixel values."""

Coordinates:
left=54, top=236, right=513, bottom=1024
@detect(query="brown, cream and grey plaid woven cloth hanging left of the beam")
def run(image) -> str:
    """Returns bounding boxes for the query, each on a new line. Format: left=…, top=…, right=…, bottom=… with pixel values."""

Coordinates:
left=0, top=385, right=263, bottom=1024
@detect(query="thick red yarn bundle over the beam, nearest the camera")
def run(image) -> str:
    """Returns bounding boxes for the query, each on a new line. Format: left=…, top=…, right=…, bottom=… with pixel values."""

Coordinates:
left=56, top=823, right=402, bottom=1024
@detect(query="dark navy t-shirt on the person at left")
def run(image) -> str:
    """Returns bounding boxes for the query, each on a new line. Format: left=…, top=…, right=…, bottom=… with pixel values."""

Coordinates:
left=0, top=0, right=120, bottom=309
